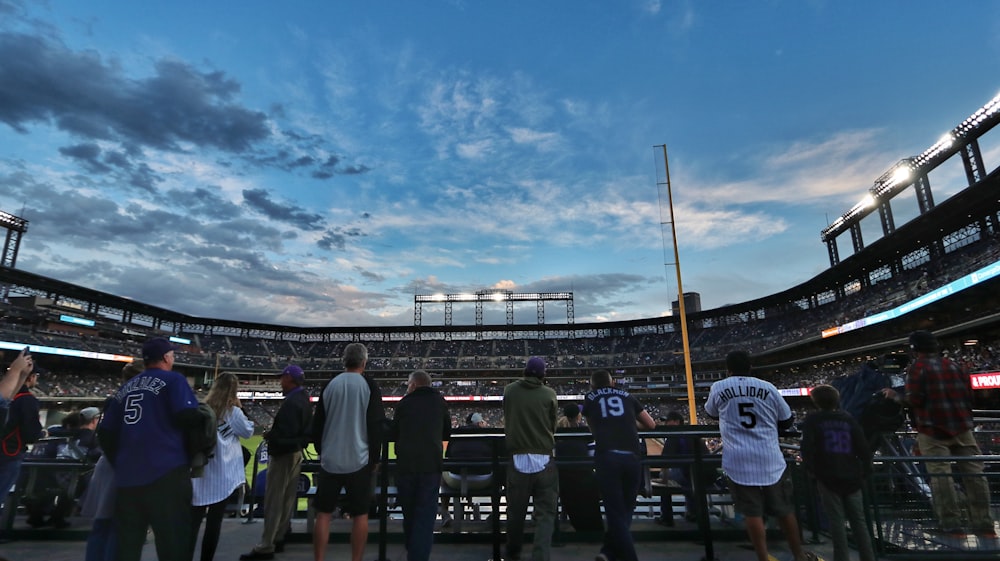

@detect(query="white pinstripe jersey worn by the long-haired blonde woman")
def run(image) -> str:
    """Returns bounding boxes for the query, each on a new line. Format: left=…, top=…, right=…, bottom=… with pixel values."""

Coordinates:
left=191, top=407, right=253, bottom=506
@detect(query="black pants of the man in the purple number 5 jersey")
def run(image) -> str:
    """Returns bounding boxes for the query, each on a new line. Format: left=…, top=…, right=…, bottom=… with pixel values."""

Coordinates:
left=115, top=466, right=192, bottom=561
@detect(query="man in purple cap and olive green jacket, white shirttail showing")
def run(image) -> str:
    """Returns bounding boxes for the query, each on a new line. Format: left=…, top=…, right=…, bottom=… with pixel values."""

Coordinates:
left=503, top=357, right=559, bottom=561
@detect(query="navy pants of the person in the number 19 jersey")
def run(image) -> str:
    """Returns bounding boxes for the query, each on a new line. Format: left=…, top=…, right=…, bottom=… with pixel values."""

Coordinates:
left=594, top=452, right=640, bottom=561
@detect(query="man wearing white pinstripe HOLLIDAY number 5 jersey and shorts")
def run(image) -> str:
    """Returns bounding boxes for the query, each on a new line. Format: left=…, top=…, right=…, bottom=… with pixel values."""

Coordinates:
left=705, top=351, right=815, bottom=561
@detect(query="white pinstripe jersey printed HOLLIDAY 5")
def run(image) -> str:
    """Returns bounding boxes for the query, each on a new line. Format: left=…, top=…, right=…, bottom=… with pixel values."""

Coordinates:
left=705, top=376, right=792, bottom=486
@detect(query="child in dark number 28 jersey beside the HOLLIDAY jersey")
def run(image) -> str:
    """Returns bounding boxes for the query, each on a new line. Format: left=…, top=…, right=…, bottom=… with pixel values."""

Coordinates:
left=800, top=384, right=875, bottom=561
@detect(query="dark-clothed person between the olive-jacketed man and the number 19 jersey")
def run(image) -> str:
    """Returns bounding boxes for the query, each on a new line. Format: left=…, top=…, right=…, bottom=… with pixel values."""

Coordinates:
left=555, top=403, right=604, bottom=532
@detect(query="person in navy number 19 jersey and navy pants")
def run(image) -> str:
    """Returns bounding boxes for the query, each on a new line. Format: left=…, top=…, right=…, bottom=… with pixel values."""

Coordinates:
left=583, top=370, right=656, bottom=561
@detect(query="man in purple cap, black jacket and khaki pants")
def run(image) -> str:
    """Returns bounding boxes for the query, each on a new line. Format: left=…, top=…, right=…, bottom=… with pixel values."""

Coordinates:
left=240, top=364, right=312, bottom=561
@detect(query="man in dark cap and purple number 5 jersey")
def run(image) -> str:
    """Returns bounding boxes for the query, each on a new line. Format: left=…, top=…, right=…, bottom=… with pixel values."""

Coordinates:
left=97, top=337, right=201, bottom=561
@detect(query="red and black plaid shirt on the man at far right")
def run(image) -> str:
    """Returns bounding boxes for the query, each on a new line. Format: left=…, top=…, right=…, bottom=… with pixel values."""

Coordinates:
left=906, top=355, right=972, bottom=438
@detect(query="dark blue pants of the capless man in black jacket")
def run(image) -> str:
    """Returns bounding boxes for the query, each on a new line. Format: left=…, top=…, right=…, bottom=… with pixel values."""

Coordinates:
left=396, top=472, right=441, bottom=561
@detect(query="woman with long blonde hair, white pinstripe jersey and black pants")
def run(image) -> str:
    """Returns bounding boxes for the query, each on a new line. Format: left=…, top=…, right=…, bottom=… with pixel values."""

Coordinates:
left=191, top=372, right=253, bottom=561
